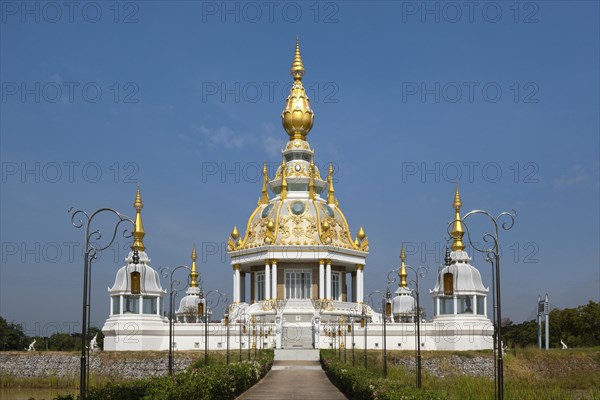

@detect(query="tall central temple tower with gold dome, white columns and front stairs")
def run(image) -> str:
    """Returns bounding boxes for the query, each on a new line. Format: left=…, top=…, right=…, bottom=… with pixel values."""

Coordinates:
left=228, top=38, right=372, bottom=347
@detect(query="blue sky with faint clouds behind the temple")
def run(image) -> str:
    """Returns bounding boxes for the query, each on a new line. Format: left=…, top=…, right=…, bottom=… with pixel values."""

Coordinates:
left=0, top=1, right=600, bottom=334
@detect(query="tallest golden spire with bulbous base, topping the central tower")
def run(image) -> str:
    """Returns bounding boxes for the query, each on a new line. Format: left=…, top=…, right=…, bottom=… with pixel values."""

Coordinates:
left=281, top=39, right=315, bottom=140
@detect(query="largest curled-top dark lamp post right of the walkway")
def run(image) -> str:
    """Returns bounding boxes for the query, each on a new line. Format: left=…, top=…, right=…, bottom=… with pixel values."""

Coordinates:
left=460, top=210, right=517, bottom=400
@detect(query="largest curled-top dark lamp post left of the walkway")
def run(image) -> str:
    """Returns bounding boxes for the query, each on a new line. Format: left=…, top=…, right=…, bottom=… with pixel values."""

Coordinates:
left=69, top=208, right=134, bottom=400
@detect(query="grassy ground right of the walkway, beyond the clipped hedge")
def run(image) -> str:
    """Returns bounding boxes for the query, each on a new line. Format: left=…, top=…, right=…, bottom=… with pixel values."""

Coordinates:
left=322, top=347, right=600, bottom=400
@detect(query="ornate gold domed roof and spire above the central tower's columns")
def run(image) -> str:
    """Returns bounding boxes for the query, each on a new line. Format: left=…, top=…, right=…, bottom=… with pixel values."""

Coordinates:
left=228, top=41, right=369, bottom=252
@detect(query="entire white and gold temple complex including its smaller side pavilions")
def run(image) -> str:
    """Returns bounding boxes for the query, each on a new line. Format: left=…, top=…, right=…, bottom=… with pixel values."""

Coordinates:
left=103, top=41, right=493, bottom=350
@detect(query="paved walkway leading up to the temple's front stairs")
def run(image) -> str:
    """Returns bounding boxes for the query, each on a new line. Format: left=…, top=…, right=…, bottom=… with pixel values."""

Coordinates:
left=238, top=361, right=346, bottom=400
